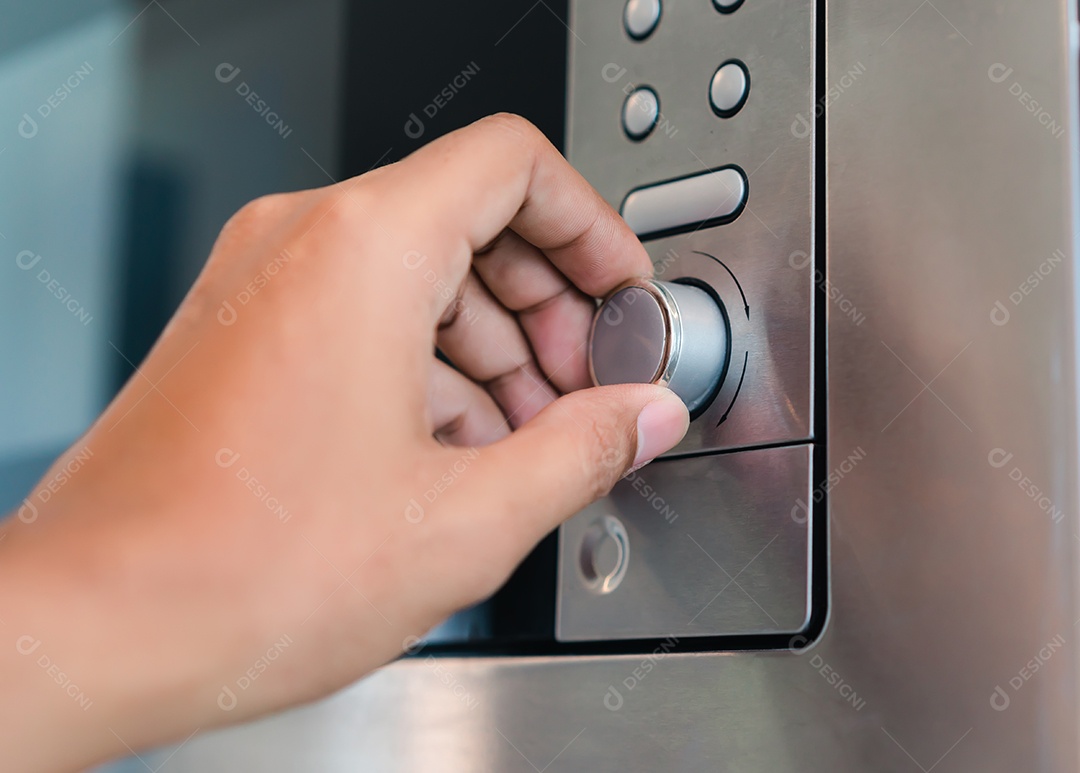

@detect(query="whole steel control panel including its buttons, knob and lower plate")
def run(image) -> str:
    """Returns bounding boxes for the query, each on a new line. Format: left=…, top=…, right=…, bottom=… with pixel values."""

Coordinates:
left=556, top=0, right=824, bottom=642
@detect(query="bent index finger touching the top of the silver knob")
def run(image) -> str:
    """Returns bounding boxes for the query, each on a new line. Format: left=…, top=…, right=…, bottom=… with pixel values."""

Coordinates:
left=378, top=114, right=652, bottom=325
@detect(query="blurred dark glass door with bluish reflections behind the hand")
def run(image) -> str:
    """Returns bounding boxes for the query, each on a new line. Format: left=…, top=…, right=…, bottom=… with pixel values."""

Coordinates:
left=0, top=0, right=567, bottom=771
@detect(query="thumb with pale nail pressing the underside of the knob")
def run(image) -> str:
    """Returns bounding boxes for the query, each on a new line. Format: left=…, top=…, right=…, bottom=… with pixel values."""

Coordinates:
left=462, top=384, right=690, bottom=539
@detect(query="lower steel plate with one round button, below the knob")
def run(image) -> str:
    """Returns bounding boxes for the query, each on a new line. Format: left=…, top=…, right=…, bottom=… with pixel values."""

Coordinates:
left=556, top=446, right=811, bottom=641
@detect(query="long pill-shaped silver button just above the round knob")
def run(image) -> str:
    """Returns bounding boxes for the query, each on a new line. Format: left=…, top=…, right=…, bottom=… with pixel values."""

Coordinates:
left=620, top=166, right=747, bottom=239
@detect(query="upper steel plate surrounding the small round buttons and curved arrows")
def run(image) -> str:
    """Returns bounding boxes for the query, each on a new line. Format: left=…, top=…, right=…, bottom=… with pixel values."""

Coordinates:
left=567, top=0, right=815, bottom=455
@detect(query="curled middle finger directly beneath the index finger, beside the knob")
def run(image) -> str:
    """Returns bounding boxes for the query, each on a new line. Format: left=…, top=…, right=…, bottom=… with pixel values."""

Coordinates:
left=473, top=230, right=596, bottom=392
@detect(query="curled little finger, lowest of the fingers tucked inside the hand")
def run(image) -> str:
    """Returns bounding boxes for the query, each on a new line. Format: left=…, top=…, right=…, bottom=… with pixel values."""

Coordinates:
left=428, top=360, right=510, bottom=446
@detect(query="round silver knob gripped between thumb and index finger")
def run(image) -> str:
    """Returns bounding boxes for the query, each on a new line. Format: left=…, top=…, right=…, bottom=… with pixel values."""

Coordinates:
left=589, top=280, right=728, bottom=412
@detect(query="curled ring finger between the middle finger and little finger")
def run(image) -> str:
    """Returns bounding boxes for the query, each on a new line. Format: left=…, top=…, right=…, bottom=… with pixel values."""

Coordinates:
left=436, top=273, right=558, bottom=428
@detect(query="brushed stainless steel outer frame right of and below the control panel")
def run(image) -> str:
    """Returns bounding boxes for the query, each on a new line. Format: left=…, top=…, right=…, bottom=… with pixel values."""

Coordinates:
left=148, top=0, right=1080, bottom=773
